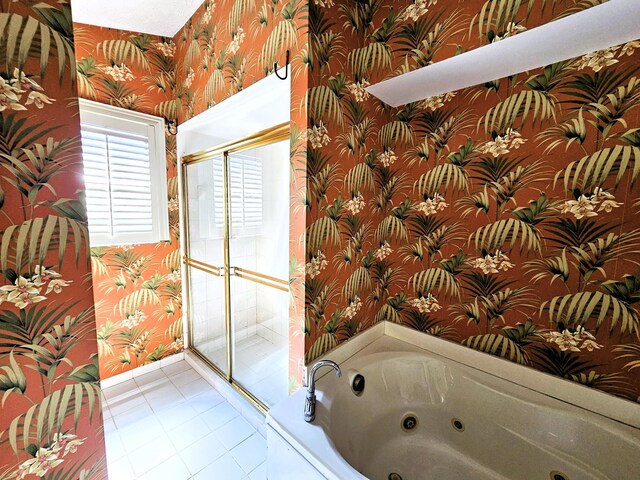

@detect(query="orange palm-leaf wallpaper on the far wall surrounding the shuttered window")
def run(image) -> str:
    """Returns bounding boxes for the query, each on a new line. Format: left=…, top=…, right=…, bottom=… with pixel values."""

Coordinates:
left=75, top=25, right=183, bottom=378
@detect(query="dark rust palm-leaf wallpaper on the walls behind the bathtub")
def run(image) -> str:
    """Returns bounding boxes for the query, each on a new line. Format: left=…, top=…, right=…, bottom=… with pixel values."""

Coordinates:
left=303, top=0, right=640, bottom=401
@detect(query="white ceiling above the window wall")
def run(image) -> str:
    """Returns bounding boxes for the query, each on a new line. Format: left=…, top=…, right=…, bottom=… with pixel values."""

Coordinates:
left=71, top=0, right=204, bottom=37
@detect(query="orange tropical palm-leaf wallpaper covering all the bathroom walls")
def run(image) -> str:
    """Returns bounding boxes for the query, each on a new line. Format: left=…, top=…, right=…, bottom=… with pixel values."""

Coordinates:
left=0, top=0, right=640, bottom=479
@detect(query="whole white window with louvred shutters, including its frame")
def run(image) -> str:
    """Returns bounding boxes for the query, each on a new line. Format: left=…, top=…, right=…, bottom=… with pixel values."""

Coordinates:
left=80, top=100, right=169, bottom=246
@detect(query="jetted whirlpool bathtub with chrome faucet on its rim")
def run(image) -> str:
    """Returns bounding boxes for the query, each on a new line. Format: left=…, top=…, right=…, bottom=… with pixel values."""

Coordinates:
left=267, top=326, right=640, bottom=480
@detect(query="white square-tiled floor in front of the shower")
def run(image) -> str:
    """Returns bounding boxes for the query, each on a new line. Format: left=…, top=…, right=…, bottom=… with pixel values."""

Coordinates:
left=103, top=361, right=267, bottom=480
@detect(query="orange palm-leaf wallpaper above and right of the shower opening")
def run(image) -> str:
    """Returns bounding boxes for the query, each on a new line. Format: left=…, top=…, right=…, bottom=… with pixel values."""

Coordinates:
left=174, top=0, right=308, bottom=389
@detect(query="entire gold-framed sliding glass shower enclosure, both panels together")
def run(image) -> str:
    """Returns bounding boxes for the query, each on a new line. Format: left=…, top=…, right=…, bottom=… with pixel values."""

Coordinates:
left=182, top=124, right=290, bottom=411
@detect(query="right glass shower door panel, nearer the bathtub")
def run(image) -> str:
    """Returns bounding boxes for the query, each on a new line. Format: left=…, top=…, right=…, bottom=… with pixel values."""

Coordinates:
left=228, top=141, right=289, bottom=406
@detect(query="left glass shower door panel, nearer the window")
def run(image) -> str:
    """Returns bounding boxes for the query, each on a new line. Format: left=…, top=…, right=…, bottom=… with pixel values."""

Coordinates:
left=185, top=155, right=230, bottom=377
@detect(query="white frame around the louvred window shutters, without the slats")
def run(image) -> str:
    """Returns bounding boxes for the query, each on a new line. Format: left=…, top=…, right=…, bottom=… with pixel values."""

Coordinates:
left=78, top=99, right=170, bottom=247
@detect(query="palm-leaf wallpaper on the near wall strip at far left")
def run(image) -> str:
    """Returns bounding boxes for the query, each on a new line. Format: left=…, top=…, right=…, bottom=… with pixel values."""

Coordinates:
left=0, top=0, right=106, bottom=480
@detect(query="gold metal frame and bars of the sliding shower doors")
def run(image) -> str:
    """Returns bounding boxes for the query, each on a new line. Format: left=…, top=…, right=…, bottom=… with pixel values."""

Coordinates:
left=180, top=123, right=289, bottom=414
